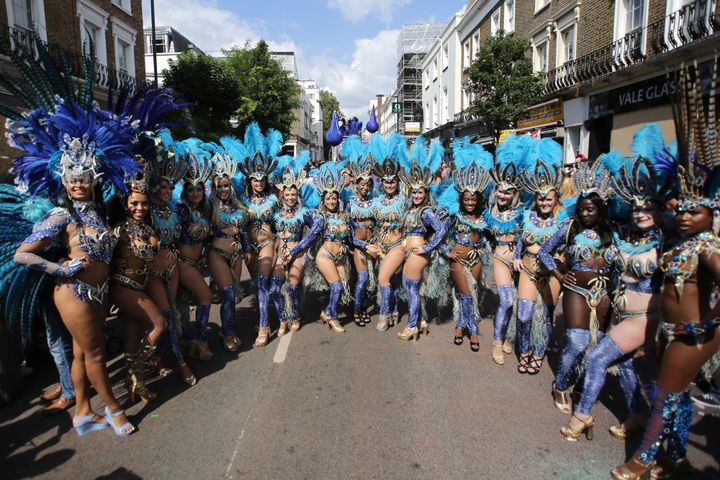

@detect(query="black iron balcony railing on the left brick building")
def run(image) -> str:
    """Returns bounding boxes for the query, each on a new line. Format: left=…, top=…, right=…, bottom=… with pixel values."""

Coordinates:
left=0, top=24, right=145, bottom=96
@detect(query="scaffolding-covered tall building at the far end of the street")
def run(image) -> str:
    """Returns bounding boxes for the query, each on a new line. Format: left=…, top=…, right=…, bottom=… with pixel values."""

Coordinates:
left=396, top=23, right=447, bottom=136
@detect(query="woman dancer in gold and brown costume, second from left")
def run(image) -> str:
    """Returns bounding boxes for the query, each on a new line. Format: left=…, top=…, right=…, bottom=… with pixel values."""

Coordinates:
left=110, top=165, right=165, bottom=402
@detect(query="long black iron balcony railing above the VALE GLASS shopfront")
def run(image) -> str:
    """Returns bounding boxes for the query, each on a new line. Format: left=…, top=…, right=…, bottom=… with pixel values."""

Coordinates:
left=543, top=0, right=720, bottom=93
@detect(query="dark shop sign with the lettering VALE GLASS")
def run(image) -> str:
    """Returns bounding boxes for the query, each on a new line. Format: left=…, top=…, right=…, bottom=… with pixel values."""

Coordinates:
left=590, top=75, right=677, bottom=118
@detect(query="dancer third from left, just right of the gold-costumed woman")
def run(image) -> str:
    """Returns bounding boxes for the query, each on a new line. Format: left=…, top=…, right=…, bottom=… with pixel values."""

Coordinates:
left=145, top=142, right=197, bottom=386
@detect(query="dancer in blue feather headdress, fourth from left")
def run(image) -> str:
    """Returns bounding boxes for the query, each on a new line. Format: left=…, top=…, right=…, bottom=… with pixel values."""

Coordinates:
left=176, top=143, right=216, bottom=360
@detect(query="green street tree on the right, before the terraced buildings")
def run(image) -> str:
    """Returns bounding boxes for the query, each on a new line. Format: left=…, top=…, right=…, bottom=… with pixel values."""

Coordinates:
left=467, top=31, right=543, bottom=143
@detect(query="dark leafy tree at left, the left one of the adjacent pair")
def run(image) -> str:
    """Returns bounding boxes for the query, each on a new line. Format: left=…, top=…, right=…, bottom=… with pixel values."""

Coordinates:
left=163, top=52, right=240, bottom=140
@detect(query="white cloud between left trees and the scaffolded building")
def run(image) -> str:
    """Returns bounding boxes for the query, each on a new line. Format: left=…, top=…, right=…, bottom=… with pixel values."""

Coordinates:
left=307, top=30, right=400, bottom=120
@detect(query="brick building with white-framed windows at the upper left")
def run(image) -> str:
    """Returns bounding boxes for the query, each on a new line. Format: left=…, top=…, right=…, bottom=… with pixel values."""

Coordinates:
left=0, top=0, right=145, bottom=171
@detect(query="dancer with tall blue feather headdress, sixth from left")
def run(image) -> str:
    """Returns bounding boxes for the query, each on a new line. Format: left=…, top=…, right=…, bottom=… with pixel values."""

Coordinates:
left=239, top=122, right=282, bottom=347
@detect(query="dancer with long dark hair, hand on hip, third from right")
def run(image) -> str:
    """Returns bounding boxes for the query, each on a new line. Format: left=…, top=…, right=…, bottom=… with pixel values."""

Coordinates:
left=539, top=160, right=612, bottom=415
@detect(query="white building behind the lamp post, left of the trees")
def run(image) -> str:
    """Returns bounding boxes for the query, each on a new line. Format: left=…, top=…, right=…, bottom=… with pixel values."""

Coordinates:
left=144, top=26, right=204, bottom=86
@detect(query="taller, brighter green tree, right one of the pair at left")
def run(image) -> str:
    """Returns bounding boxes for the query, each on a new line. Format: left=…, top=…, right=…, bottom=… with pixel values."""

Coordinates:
left=223, top=40, right=300, bottom=135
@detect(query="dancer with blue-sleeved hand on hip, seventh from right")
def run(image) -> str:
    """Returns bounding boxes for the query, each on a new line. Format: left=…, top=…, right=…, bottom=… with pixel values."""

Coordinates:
left=398, top=135, right=447, bottom=340
